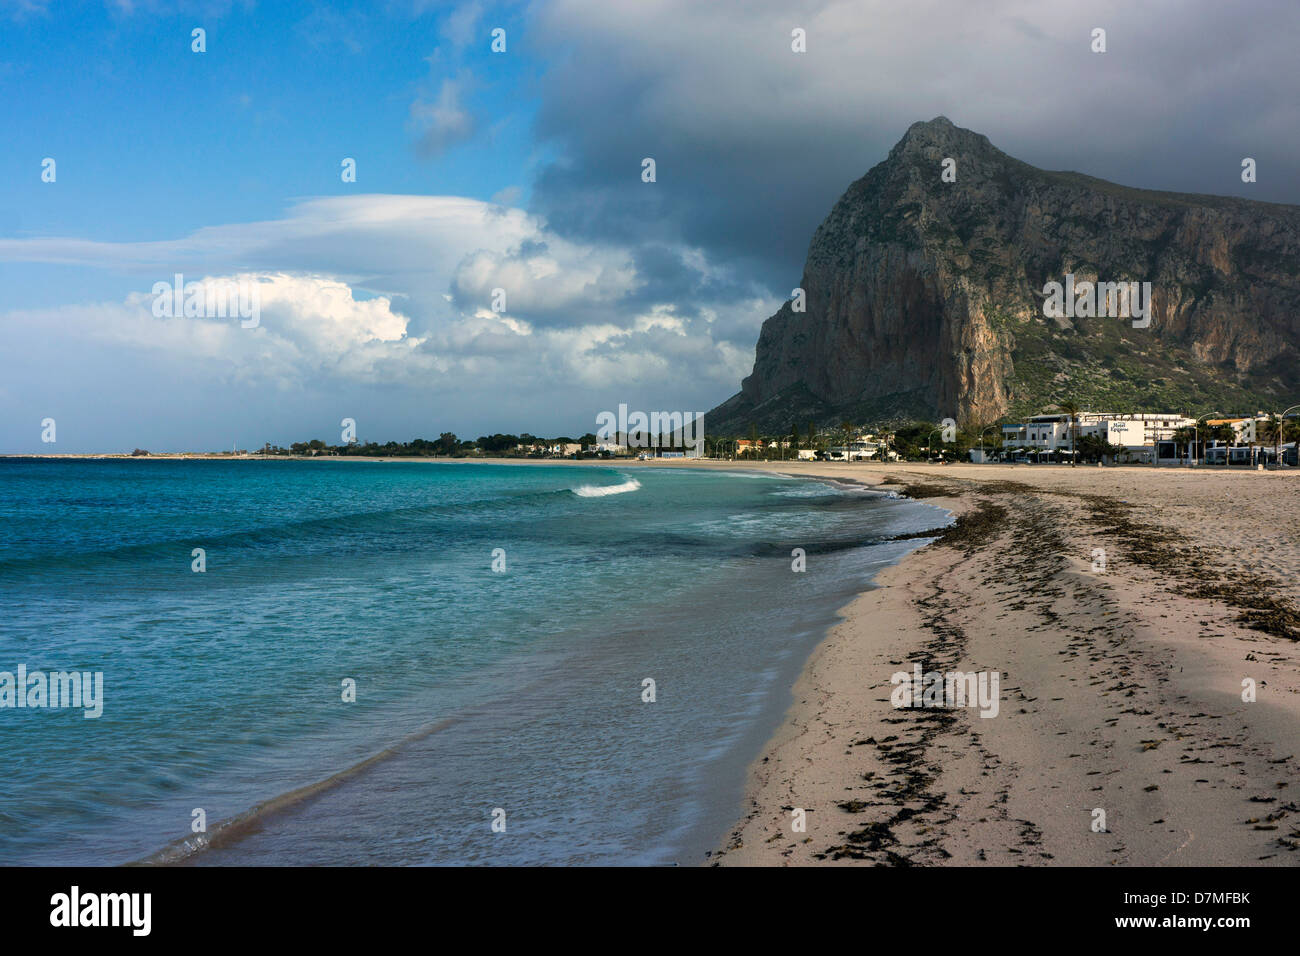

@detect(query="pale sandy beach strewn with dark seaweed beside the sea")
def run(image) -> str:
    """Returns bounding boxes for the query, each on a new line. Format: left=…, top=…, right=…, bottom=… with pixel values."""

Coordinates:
left=660, top=462, right=1300, bottom=866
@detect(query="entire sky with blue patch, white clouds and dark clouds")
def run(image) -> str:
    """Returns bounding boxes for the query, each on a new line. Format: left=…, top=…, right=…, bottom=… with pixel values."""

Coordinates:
left=0, top=0, right=1300, bottom=454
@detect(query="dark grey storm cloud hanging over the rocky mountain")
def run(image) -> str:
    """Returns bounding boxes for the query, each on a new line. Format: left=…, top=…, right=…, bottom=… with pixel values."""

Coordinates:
left=528, top=0, right=1300, bottom=291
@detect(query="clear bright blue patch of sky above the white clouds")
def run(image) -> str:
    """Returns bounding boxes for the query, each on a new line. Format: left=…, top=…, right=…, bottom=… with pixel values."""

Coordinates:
left=0, top=3, right=540, bottom=299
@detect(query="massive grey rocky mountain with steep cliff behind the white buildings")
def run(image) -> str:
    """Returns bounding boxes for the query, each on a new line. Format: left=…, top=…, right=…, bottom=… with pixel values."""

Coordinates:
left=707, top=117, right=1300, bottom=433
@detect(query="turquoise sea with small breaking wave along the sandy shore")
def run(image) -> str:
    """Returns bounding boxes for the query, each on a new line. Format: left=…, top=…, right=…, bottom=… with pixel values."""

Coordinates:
left=0, top=459, right=949, bottom=865
